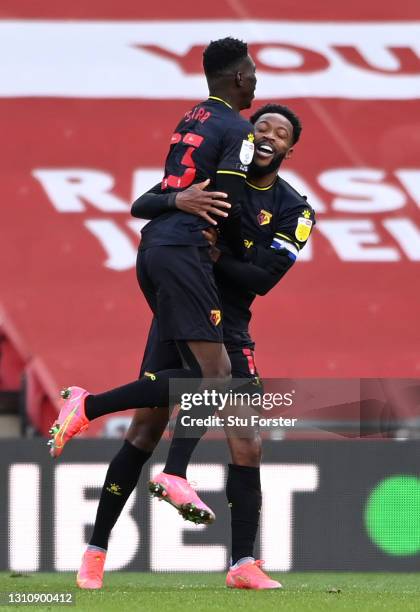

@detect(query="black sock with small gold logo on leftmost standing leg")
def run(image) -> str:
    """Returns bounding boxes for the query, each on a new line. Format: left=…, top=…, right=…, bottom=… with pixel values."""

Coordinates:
left=89, top=440, right=152, bottom=550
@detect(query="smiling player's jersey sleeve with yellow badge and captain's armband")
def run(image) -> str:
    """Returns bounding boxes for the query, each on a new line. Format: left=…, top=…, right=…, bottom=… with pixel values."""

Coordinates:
left=270, top=202, right=315, bottom=261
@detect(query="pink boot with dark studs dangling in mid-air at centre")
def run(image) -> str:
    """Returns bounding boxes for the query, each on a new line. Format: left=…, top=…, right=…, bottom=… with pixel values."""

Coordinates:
left=149, top=472, right=216, bottom=525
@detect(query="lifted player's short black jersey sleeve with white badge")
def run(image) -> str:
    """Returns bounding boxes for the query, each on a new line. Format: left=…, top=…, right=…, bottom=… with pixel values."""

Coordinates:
left=216, top=121, right=254, bottom=179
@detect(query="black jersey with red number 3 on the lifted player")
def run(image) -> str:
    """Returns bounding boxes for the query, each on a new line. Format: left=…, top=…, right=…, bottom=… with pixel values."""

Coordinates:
left=141, top=97, right=254, bottom=250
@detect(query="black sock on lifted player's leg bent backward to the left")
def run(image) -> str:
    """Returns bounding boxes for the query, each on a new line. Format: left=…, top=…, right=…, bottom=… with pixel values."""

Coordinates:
left=85, top=369, right=193, bottom=421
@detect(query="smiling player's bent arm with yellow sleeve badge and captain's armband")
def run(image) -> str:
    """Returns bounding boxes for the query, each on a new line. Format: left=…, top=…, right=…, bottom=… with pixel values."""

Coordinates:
left=216, top=206, right=315, bottom=295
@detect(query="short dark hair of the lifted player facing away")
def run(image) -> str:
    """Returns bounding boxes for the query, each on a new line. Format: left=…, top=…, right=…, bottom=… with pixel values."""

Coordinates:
left=203, top=36, right=248, bottom=78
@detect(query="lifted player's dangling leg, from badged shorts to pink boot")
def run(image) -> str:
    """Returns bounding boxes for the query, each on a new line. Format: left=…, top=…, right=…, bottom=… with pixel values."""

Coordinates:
left=150, top=249, right=230, bottom=523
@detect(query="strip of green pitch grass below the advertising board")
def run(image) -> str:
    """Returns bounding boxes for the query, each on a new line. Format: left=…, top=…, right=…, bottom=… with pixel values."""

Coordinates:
left=0, top=572, right=420, bottom=612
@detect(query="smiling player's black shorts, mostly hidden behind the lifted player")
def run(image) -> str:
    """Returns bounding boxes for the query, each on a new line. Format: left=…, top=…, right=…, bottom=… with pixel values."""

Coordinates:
left=140, top=319, right=258, bottom=379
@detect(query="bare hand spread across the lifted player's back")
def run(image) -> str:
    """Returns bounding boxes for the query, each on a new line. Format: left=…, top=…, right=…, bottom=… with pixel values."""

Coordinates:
left=175, top=179, right=230, bottom=225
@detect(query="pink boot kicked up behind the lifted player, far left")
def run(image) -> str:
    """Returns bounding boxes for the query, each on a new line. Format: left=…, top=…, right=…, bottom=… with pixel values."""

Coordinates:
left=48, top=387, right=89, bottom=458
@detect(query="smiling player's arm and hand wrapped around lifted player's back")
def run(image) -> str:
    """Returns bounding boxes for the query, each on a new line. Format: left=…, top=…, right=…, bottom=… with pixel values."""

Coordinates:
left=131, top=180, right=230, bottom=225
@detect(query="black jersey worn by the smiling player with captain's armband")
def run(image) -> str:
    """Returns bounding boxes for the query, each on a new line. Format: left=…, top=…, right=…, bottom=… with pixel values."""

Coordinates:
left=215, top=177, right=315, bottom=348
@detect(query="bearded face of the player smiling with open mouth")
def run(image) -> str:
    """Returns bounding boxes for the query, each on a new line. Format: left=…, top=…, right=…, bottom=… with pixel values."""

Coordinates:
left=253, top=113, right=293, bottom=168
